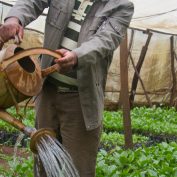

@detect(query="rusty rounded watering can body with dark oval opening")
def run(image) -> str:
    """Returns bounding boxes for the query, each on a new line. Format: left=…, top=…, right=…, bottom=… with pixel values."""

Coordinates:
left=0, top=45, right=43, bottom=109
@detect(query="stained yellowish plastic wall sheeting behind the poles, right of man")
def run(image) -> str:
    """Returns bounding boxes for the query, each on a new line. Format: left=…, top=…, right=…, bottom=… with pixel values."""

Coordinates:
left=105, top=30, right=177, bottom=106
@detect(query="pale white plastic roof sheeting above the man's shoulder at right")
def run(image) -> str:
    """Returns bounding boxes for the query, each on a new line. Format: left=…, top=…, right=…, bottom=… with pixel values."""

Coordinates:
left=130, top=0, right=177, bottom=35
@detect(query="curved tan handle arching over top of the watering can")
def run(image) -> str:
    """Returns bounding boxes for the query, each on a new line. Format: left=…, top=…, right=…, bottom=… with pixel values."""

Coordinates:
left=0, top=47, right=62, bottom=77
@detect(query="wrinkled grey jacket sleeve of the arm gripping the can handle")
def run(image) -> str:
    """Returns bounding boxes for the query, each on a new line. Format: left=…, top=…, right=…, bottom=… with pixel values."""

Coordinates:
left=73, top=2, right=134, bottom=67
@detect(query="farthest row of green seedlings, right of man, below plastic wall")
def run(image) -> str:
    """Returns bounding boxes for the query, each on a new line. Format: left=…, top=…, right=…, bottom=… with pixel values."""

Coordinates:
left=103, top=107, right=177, bottom=135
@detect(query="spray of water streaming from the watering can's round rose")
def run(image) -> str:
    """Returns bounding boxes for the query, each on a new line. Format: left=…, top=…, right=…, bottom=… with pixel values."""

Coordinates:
left=36, top=135, right=79, bottom=177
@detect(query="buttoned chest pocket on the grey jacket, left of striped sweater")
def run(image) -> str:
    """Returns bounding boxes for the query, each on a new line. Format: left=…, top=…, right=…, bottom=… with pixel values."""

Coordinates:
left=46, top=0, right=69, bottom=30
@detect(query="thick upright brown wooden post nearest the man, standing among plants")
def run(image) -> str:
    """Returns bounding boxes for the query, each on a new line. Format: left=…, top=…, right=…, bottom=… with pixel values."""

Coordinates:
left=120, top=32, right=133, bottom=149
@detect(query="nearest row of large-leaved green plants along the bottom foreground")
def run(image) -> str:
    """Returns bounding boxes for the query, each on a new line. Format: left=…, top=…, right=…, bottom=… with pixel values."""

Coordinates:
left=0, top=142, right=177, bottom=177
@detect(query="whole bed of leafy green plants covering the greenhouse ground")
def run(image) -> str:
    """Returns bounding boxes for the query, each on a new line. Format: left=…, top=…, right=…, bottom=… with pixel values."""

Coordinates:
left=0, top=107, right=177, bottom=177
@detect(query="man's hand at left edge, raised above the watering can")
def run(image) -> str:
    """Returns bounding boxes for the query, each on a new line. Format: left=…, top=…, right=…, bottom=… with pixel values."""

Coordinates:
left=0, top=17, right=24, bottom=43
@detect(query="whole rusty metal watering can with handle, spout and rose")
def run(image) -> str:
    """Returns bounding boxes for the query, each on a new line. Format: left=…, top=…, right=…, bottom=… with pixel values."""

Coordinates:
left=0, top=44, right=61, bottom=153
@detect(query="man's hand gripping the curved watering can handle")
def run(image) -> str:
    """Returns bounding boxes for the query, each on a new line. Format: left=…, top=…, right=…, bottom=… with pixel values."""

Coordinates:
left=55, top=49, right=77, bottom=72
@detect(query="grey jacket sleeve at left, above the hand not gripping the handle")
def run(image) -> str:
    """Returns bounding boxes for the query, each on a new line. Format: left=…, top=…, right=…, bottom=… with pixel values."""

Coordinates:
left=5, top=0, right=50, bottom=27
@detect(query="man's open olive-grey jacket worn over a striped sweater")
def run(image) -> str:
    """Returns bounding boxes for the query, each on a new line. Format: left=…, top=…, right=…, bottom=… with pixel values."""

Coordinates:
left=7, top=0, right=134, bottom=130
